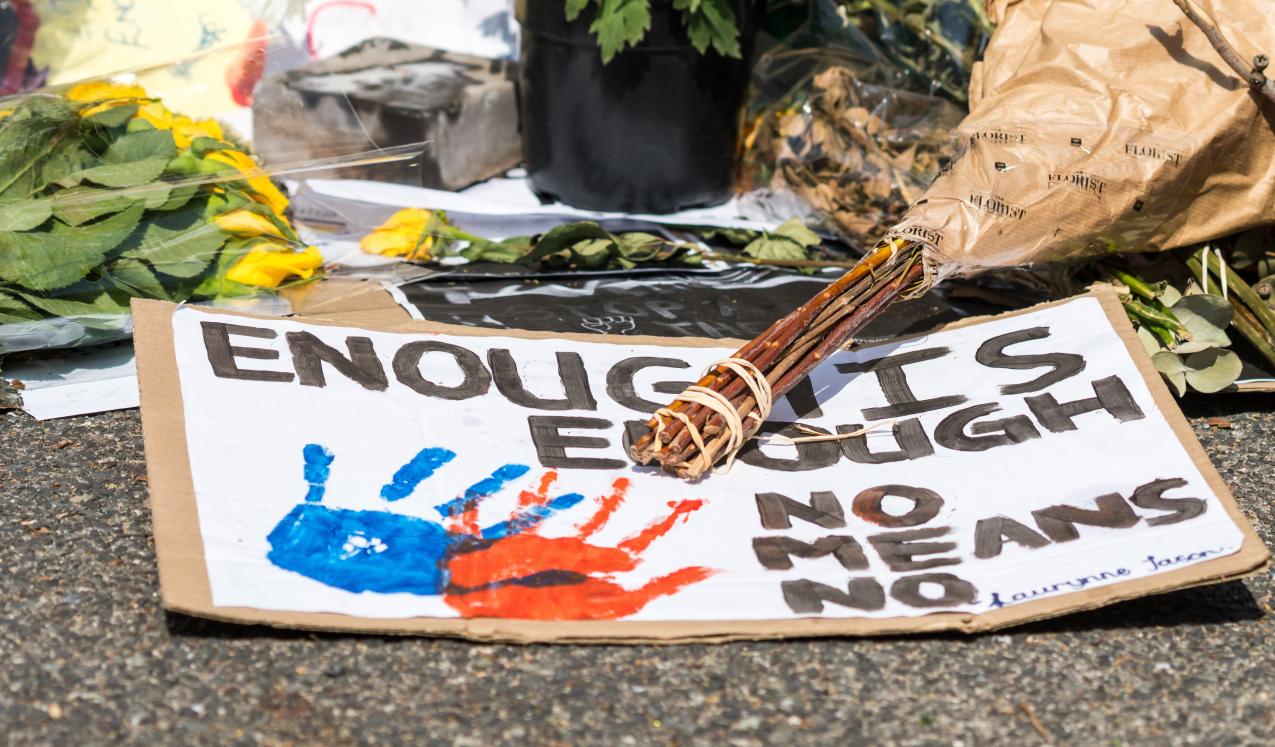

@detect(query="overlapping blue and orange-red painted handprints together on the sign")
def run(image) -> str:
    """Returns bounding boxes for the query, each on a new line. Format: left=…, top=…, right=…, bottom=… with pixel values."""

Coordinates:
left=266, top=444, right=711, bottom=620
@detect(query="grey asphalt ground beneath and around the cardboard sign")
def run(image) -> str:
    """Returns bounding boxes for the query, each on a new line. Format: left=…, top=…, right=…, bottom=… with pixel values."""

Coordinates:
left=0, top=396, right=1275, bottom=746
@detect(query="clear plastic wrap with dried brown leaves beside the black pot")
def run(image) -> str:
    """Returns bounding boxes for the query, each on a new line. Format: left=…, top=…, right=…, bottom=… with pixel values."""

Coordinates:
left=740, top=0, right=991, bottom=249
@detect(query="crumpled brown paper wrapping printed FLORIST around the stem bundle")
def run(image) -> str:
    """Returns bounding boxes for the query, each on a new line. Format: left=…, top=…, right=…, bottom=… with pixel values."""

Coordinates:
left=890, top=0, right=1275, bottom=278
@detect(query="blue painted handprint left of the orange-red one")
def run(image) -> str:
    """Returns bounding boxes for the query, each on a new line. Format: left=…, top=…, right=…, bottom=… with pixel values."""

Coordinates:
left=266, top=444, right=584, bottom=595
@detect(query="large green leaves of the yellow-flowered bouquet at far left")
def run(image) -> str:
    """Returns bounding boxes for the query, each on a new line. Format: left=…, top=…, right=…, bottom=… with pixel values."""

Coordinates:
left=0, top=89, right=297, bottom=346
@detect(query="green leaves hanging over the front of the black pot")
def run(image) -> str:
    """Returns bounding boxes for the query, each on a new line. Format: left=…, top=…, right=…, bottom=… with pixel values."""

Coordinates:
left=566, top=0, right=740, bottom=62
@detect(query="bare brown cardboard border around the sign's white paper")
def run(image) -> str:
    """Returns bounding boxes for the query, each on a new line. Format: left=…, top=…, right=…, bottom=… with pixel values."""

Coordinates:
left=134, top=287, right=1270, bottom=644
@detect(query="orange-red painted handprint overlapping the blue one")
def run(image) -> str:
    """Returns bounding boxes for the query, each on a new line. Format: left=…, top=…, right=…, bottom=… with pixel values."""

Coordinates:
left=444, top=472, right=713, bottom=620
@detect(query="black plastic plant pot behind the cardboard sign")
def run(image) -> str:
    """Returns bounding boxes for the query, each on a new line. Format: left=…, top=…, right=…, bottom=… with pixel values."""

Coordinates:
left=519, top=0, right=756, bottom=213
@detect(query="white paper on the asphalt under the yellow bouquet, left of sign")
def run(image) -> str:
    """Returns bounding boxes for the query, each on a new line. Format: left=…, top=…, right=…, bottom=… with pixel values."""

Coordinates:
left=4, top=343, right=138, bottom=421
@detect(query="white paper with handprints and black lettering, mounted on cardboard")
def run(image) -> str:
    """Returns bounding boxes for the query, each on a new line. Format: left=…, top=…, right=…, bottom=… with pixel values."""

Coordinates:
left=173, top=293, right=1243, bottom=621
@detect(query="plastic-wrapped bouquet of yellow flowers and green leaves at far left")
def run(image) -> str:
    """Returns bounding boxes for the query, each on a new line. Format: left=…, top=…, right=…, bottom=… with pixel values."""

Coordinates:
left=0, top=43, right=423, bottom=353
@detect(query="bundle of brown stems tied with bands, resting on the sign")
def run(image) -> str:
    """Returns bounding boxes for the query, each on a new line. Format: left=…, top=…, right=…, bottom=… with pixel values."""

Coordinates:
left=629, top=238, right=928, bottom=479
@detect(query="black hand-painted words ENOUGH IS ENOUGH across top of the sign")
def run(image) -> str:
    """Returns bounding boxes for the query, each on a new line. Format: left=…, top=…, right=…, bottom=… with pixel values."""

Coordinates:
left=200, top=316, right=1145, bottom=472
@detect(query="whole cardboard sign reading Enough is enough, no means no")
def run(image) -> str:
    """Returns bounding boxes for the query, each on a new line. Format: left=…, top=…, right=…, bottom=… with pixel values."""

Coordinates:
left=134, top=286, right=1269, bottom=641
